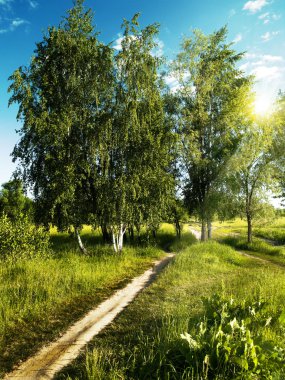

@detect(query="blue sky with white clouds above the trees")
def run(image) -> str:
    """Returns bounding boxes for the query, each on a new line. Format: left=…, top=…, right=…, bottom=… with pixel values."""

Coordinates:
left=0, top=0, right=285, bottom=184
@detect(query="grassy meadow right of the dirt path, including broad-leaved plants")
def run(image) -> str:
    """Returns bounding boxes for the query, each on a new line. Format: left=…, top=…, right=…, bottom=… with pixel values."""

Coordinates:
left=57, top=224, right=285, bottom=380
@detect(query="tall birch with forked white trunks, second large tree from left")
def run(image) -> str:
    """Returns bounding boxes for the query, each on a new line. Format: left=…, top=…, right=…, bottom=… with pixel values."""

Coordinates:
left=96, top=14, right=172, bottom=252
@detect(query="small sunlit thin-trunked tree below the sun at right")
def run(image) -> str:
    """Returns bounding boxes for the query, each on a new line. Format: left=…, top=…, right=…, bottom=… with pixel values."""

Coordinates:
left=223, top=117, right=278, bottom=243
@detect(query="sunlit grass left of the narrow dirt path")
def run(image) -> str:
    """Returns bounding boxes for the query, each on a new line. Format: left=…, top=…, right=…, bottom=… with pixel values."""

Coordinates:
left=0, top=225, right=174, bottom=377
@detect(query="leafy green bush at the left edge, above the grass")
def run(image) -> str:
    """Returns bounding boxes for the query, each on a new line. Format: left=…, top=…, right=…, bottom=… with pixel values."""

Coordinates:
left=0, top=215, right=49, bottom=260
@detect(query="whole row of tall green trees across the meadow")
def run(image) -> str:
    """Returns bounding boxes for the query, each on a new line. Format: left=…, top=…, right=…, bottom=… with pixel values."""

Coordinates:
left=3, top=0, right=285, bottom=252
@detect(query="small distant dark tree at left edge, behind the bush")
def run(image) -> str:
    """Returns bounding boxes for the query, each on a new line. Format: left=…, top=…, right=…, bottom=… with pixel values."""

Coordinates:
left=0, top=179, right=33, bottom=222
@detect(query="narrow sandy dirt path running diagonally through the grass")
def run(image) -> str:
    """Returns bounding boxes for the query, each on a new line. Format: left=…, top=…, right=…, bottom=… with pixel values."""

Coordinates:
left=4, top=253, right=174, bottom=380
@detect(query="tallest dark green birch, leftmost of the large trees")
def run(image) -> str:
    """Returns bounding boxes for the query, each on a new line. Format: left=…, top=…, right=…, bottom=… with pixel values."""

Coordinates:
left=9, top=0, right=113, bottom=255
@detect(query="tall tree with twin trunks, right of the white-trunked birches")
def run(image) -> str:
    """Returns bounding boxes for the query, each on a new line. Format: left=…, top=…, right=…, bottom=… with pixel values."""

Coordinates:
left=172, top=27, right=251, bottom=240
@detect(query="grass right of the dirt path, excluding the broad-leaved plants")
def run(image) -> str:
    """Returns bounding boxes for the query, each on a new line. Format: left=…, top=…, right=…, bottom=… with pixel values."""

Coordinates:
left=57, top=234, right=285, bottom=380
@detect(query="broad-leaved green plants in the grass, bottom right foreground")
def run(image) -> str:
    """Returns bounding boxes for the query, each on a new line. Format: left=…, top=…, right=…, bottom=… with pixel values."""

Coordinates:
left=181, top=294, right=285, bottom=379
